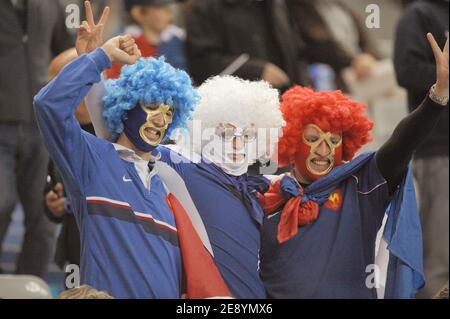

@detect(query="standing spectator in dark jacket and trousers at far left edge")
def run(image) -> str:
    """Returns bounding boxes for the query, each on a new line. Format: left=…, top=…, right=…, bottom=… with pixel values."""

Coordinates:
left=0, top=0, right=73, bottom=276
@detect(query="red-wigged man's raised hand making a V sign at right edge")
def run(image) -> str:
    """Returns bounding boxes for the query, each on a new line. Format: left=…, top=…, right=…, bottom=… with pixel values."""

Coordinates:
left=427, top=33, right=449, bottom=97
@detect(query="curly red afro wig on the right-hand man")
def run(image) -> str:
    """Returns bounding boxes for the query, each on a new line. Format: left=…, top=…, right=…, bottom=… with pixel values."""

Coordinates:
left=278, top=86, right=373, bottom=166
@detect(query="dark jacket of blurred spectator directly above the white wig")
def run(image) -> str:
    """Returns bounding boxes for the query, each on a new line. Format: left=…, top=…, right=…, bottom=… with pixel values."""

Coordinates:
left=187, top=0, right=310, bottom=85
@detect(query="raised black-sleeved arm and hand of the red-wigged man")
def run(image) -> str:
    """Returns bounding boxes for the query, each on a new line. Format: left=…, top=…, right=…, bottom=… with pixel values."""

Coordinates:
left=376, top=33, right=449, bottom=194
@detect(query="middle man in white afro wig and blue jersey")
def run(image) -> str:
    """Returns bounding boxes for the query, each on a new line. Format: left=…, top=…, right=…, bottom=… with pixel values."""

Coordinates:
left=157, top=76, right=284, bottom=299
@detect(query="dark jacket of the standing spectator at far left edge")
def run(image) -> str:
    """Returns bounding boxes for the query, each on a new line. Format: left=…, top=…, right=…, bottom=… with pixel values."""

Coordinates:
left=0, top=0, right=74, bottom=123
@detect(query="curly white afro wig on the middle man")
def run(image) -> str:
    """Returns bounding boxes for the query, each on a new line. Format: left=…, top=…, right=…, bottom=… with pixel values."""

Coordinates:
left=178, top=76, right=285, bottom=160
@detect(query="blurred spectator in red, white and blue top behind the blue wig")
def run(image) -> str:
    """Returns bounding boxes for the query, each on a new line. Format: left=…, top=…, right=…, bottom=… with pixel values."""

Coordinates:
left=106, top=0, right=186, bottom=79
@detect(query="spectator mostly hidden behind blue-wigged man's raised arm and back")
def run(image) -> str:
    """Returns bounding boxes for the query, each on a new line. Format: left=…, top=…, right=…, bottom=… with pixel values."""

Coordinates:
left=45, top=48, right=95, bottom=268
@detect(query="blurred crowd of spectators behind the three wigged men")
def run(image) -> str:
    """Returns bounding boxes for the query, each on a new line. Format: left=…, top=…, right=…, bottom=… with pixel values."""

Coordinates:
left=0, top=0, right=449, bottom=298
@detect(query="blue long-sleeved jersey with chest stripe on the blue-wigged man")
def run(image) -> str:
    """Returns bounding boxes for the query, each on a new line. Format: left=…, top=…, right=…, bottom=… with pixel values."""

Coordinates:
left=35, top=49, right=182, bottom=298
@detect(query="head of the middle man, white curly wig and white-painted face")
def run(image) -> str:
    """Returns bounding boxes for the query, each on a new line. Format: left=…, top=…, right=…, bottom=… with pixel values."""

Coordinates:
left=191, top=76, right=283, bottom=176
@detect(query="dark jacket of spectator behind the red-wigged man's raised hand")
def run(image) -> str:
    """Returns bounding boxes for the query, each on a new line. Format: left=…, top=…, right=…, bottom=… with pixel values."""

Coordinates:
left=394, top=0, right=449, bottom=158
